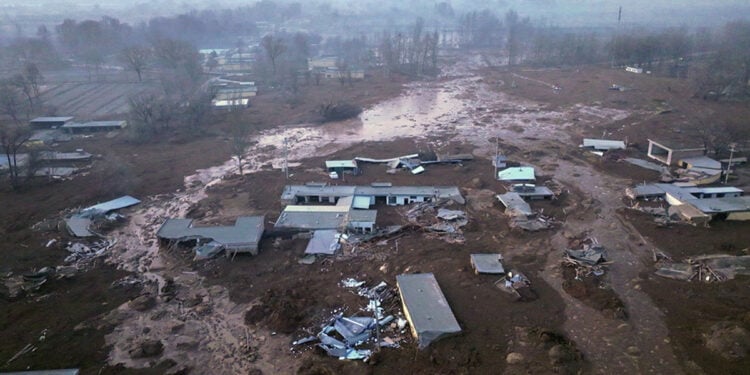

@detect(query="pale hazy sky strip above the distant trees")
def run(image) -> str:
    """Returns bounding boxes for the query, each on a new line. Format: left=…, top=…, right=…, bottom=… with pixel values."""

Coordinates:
left=0, top=0, right=750, bottom=27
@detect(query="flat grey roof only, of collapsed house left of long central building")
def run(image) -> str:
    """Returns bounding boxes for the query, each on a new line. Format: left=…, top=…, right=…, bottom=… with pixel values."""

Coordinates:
left=156, top=216, right=265, bottom=247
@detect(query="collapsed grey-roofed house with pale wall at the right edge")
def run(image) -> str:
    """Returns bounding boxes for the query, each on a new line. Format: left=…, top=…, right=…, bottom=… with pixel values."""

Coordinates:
left=625, top=183, right=750, bottom=224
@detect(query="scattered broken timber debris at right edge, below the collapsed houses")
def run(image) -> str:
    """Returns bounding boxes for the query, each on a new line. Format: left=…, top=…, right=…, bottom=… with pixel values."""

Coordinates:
left=654, top=254, right=750, bottom=283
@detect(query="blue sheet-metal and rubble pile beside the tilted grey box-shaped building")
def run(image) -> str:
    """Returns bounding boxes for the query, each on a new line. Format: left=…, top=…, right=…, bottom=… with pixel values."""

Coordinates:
left=292, top=278, right=407, bottom=361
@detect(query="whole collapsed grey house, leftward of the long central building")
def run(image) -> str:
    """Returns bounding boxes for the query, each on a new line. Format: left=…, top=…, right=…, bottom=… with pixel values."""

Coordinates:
left=156, top=216, right=265, bottom=259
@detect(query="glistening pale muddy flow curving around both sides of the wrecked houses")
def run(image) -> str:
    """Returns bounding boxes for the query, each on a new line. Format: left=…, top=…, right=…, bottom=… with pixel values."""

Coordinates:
left=107, top=56, right=678, bottom=373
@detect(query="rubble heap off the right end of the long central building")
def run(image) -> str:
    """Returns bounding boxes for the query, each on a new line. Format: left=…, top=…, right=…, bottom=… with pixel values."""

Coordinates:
left=406, top=200, right=469, bottom=243
